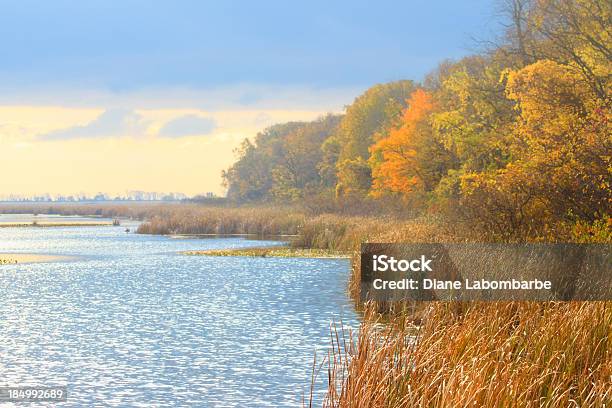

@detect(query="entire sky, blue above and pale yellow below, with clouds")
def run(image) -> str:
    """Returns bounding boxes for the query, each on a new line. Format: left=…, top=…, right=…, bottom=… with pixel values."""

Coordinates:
left=0, top=0, right=496, bottom=195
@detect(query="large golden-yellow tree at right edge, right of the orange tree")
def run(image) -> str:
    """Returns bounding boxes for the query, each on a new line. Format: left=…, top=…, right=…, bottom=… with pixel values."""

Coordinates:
left=507, top=60, right=612, bottom=220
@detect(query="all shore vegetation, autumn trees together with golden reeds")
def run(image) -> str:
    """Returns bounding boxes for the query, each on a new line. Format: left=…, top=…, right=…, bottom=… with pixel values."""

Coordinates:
left=2, top=0, right=612, bottom=408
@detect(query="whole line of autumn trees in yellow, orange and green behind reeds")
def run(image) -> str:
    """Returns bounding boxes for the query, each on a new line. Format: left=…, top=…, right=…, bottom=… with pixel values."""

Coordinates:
left=223, top=0, right=612, bottom=239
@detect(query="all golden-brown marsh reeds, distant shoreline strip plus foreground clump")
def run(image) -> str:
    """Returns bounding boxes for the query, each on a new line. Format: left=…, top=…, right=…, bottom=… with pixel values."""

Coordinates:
left=0, top=201, right=612, bottom=408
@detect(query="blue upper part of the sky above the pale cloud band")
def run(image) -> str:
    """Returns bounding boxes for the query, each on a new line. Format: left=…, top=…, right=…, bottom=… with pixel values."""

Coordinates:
left=0, top=0, right=495, bottom=92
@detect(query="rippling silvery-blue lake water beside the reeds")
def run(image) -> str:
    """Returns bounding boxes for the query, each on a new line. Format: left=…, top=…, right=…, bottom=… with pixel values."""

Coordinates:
left=0, top=218, right=357, bottom=407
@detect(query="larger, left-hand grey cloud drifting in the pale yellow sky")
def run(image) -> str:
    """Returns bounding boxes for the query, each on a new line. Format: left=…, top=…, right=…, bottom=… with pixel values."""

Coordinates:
left=39, top=108, right=149, bottom=140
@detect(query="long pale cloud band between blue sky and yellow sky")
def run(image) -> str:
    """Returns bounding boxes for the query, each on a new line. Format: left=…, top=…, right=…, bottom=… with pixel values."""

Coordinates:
left=0, top=81, right=358, bottom=112
